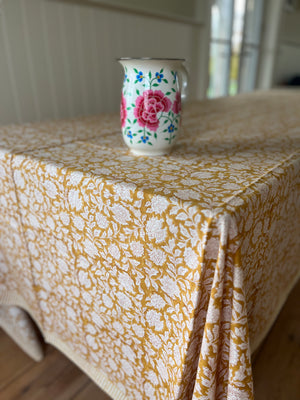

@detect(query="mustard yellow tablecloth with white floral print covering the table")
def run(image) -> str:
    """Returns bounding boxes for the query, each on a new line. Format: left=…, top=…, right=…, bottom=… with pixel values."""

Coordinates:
left=0, top=90, right=300, bottom=400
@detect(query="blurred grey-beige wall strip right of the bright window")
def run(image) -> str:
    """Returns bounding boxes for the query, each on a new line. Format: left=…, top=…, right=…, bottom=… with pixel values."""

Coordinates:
left=274, top=6, right=300, bottom=85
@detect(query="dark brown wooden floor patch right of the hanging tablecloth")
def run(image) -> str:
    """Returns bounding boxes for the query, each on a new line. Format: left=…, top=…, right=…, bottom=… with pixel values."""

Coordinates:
left=253, top=281, right=300, bottom=400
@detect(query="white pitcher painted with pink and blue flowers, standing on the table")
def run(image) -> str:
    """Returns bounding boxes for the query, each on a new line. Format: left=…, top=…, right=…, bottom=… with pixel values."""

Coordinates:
left=118, top=58, right=187, bottom=156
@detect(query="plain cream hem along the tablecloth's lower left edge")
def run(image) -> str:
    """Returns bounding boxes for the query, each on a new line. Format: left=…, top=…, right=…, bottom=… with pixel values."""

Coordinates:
left=0, top=292, right=128, bottom=400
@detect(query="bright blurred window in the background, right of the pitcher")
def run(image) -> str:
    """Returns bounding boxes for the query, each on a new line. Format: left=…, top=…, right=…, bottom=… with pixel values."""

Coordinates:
left=207, top=0, right=263, bottom=98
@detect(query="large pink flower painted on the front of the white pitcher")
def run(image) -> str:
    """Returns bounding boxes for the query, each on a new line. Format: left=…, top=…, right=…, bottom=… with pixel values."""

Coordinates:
left=134, top=90, right=172, bottom=132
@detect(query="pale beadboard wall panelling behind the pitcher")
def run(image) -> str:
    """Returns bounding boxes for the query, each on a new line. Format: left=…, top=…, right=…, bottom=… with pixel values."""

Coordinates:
left=0, top=0, right=209, bottom=124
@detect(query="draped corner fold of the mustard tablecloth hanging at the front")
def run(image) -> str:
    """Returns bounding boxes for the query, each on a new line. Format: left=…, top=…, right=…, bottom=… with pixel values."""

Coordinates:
left=193, top=214, right=253, bottom=399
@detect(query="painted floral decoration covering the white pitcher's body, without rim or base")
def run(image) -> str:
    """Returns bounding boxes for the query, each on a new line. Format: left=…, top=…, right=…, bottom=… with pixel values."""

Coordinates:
left=121, top=66, right=181, bottom=147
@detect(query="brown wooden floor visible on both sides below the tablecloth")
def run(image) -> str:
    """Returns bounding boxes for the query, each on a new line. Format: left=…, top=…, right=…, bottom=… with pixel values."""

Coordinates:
left=0, top=282, right=300, bottom=400
